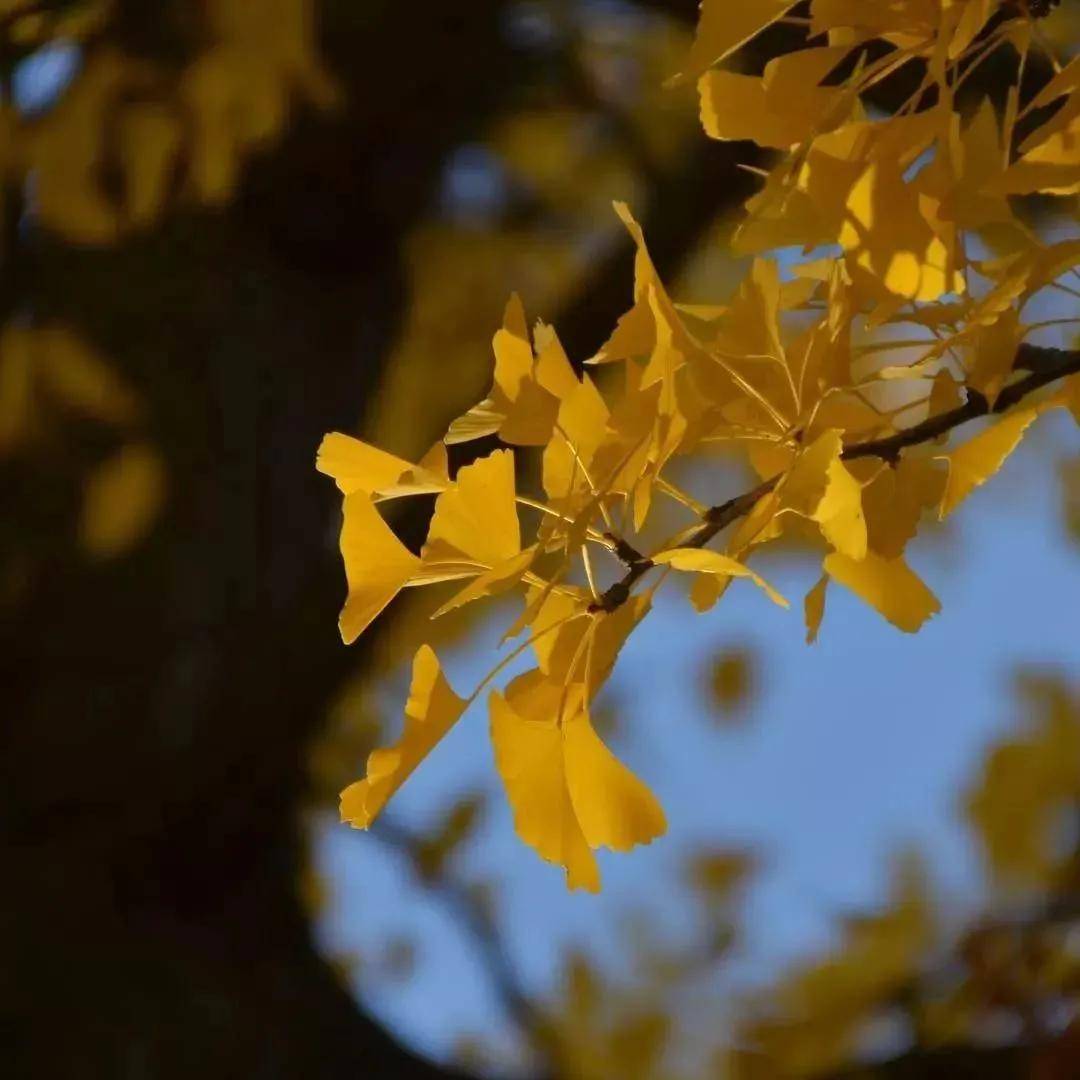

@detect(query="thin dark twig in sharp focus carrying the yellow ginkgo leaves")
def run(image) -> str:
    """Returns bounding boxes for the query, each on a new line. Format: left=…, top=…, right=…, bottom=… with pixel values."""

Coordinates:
left=590, top=342, right=1080, bottom=612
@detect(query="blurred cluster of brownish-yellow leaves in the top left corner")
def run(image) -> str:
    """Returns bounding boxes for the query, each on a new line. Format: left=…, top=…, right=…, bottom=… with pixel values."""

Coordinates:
left=0, top=0, right=335, bottom=244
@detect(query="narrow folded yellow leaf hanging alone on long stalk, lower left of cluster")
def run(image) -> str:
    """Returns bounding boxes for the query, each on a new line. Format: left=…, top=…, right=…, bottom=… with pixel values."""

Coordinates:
left=341, top=645, right=468, bottom=828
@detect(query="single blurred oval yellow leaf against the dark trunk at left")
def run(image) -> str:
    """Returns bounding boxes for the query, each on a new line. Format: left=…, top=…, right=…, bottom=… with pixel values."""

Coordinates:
left=79, top=443, right=165, bottom=558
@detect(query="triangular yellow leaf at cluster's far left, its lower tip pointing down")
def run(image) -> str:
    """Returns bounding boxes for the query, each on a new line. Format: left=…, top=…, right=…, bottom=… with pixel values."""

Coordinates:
left=338, top=491, right=421, bottom=645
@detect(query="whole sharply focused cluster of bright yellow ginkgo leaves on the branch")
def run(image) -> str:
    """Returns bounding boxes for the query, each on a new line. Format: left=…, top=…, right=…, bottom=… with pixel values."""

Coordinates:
left=319, top=0, right=1080, bottom=890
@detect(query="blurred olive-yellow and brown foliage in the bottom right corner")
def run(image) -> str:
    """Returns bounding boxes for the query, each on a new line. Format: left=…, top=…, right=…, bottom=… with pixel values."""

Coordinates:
left=724, top=671, right=1080, bottom=1080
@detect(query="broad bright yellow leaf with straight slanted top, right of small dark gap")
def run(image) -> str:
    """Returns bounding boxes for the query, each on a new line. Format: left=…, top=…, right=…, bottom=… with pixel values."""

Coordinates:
left=421, top=450, right=522, bottom=572
